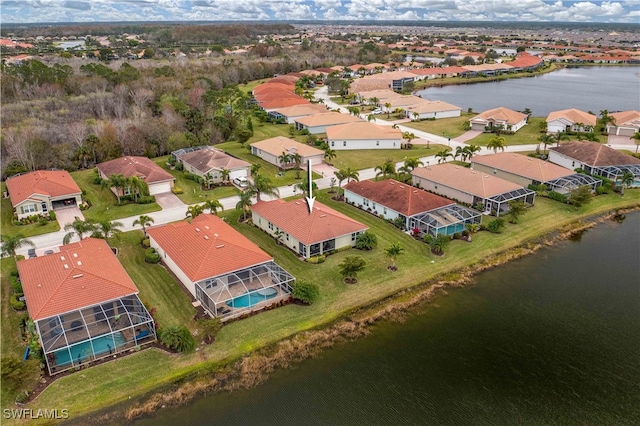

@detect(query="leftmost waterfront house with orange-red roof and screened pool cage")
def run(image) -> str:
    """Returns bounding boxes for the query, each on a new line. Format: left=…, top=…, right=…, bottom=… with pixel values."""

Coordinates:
left=18, top=238, right=156, bottom=374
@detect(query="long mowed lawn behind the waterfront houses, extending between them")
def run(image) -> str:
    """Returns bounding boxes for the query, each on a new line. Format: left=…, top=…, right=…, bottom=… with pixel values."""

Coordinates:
left=15, top=190, right=640, bottom=417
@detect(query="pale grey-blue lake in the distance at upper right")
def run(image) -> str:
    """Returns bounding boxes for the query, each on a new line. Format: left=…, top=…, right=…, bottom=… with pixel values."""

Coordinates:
left=417, top=66, right=640, bottom=117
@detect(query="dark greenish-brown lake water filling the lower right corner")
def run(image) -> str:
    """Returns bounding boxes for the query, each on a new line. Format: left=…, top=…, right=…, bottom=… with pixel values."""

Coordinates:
left=138, top=213, right=640, bottom=425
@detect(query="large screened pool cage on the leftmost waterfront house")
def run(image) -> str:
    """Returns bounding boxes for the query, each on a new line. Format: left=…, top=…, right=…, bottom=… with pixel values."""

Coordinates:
left=36, top=294, right=156, bottom=374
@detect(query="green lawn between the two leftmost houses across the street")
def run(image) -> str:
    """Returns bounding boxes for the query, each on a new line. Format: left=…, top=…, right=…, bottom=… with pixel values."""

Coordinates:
left=71, top=169, right=160, bottom=221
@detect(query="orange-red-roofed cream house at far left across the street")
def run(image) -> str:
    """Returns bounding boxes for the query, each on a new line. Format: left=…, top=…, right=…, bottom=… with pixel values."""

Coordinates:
left=5, top=170, right=82, bottom=219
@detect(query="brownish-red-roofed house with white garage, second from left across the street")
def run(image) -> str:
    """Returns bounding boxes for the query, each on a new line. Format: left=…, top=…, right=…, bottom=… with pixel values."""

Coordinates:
left=96, top=156, right=175, bottom=195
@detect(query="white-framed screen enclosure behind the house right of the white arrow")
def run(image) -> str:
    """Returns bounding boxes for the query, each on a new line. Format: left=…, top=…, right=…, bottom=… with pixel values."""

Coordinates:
left=409, top=204, right=482, bottom=237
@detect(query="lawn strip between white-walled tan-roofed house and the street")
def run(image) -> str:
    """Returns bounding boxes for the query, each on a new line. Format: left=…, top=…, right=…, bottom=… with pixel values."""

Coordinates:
left=331, top=144, right=445, bottom=170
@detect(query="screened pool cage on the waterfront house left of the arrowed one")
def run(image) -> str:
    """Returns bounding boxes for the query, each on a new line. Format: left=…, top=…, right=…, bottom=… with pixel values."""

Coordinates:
left=195, top=261, right=295, bottom=320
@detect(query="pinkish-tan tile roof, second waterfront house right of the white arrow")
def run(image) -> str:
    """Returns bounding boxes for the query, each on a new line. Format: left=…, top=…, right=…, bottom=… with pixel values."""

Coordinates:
left=411, top=163, right=522, bottom=198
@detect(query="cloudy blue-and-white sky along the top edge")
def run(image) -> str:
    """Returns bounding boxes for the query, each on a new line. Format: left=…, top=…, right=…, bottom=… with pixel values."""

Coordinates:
left=0, top=0, right=640, bottom=23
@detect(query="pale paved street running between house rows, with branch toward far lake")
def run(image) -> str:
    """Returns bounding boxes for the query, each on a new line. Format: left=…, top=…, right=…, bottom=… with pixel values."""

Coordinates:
left=17, top=86, right=631, bottom=256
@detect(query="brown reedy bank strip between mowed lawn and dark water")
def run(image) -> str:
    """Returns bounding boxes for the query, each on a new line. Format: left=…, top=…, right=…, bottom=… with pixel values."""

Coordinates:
left=73, top=205, right=640, bottom=424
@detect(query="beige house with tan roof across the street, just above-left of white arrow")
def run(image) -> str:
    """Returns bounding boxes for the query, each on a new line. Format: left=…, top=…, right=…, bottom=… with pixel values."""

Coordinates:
left=251, top=136, right=324, bottom=169
